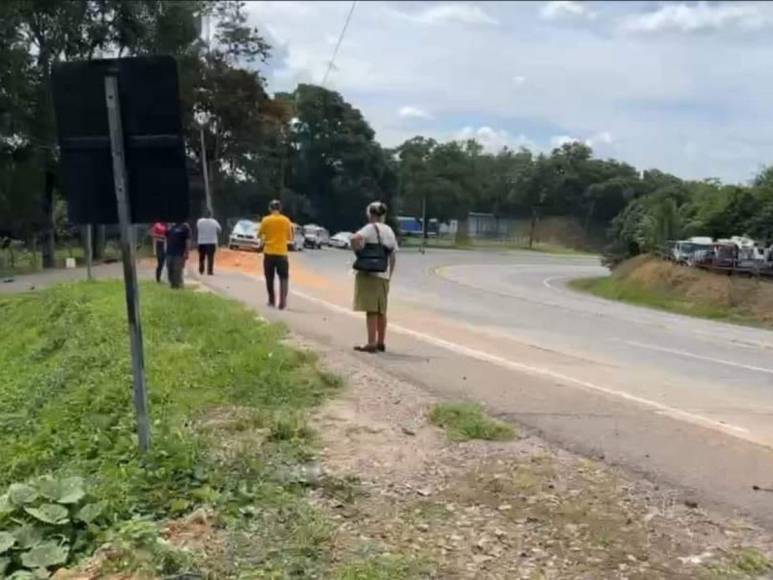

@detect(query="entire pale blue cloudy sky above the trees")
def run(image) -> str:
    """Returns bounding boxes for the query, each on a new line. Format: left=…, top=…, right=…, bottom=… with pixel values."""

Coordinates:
left=247, top=1, right=773, bottom=181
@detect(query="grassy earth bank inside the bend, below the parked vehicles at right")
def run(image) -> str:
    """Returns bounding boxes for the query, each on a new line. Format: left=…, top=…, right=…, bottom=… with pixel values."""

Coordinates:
left=570, top=256, right=773, bottom=328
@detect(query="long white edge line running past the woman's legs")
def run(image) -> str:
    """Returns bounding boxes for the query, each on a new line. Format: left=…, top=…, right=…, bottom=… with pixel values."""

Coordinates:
left=237, top=274, right=750, bottom=436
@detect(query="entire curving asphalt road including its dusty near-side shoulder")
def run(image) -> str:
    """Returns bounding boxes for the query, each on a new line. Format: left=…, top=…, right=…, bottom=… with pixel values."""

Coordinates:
left=199, top=249, right=773, bottom=523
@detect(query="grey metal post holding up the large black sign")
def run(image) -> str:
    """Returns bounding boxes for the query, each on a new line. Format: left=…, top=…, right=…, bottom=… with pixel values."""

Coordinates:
left=105, top=76, right=150, bottom=453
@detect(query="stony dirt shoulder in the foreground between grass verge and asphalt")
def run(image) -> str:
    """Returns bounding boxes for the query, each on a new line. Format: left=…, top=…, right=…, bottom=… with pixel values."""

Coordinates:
left=298, top=344, right=773, bottom=579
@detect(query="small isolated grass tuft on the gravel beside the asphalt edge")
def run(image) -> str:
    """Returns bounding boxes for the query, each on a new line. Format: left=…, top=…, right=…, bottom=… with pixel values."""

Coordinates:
left=429, top=403, right=516, bottom=441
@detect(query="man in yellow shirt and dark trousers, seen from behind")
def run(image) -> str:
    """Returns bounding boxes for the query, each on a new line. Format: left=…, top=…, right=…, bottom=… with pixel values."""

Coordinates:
left=260, top=199, right=293, bottom=310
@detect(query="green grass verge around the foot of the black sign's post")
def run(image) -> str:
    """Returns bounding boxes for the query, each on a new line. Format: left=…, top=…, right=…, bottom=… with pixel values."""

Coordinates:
left=0, top=282, right=337, bottom=578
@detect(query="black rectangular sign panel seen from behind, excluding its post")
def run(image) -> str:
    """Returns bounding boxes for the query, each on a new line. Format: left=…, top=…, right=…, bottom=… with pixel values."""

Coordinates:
left=52, top=56, right=190, bottom=224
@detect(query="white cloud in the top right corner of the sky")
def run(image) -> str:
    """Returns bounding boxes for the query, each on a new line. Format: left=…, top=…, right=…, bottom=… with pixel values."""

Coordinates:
left=625, top=2, right=771, bottom=32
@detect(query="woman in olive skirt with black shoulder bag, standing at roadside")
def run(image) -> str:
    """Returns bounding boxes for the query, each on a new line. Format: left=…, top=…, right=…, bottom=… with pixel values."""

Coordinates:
left=351, top=201, right=398, bottom=353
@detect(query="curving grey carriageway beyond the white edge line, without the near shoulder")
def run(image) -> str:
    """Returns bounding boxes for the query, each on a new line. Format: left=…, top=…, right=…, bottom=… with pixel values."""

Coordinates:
left=292, top=246, right=773, bottom=446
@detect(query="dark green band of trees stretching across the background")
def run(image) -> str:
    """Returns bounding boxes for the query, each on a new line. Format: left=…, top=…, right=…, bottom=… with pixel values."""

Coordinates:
left=0, top=0, right=773, bottom=256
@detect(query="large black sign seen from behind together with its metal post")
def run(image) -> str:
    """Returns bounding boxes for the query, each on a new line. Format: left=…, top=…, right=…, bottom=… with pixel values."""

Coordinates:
left=52, top=56, right=190, bottom=453
